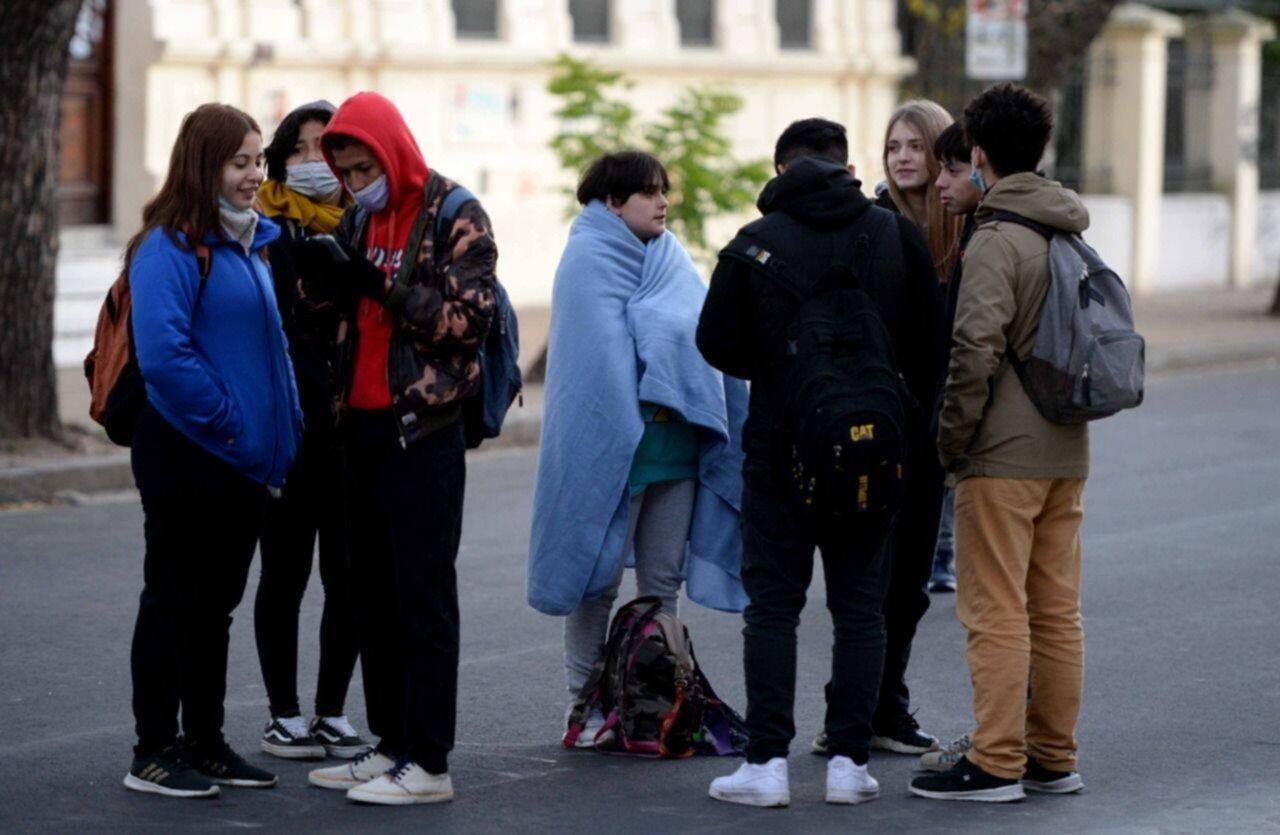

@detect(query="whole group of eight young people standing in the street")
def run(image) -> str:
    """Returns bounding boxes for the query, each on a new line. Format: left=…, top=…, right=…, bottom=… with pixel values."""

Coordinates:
left=117, top=85, right=1088, bottom=806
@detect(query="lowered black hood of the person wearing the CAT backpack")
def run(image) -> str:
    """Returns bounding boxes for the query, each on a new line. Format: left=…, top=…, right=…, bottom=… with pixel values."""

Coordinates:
left=755, top=156, right=870, bottom=229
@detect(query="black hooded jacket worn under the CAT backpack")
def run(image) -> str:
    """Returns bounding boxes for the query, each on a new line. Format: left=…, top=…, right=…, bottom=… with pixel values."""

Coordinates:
left=698, top=156, right=946, bottom=490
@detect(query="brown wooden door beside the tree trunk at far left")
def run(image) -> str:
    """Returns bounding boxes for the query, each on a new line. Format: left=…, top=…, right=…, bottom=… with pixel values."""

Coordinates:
left=58, top=0, right=111, bottom=225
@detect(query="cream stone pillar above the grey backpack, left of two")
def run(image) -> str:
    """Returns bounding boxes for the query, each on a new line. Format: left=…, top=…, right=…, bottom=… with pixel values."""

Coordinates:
left=1084, top=3, right=1183, bottom=293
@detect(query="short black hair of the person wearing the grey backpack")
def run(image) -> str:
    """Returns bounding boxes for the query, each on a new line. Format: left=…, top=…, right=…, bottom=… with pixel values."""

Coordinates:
left=964, top=82, right=1053, bottom=177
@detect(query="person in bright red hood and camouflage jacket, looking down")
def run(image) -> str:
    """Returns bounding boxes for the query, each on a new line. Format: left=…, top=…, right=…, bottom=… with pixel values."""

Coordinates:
left=297, top=92, right=498, bottom=804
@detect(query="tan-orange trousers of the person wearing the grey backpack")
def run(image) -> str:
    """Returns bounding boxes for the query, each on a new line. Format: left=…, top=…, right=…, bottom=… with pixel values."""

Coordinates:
left=955, top=478, right=1084, bottom=779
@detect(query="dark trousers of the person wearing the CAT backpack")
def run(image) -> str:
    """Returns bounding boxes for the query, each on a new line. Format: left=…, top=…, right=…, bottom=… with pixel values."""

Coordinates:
left=742, top=485, right=887, bottom=763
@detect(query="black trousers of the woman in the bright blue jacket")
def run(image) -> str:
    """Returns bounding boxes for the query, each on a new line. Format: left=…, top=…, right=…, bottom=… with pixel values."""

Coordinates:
left=132, top=406, right=266, bottom=756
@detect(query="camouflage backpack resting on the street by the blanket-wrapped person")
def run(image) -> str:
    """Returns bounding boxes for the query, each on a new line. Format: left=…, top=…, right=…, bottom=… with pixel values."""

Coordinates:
left=563, top=597, right=746, bottom=758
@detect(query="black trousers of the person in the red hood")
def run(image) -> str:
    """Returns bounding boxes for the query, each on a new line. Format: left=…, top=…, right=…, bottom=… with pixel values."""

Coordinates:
left=346, top=410, right=466, bottom=774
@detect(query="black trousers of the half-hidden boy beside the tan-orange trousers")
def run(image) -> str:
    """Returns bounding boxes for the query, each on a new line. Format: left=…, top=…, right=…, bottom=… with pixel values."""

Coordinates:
left=872, top=446, right=945, bottom=731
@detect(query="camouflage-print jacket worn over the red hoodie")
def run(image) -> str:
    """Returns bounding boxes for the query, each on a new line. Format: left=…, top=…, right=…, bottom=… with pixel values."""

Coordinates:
left=335, top=172, right=498, bottom=444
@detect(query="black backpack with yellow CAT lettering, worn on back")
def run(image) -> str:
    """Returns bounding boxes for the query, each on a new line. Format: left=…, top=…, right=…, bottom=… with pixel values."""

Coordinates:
left=740, top=209, right=919, bottom=526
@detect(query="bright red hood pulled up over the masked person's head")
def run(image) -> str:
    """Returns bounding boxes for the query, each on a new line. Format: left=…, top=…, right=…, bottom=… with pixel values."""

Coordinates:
left=324, top=91, right=431, bottom=207
